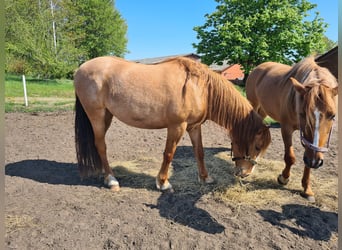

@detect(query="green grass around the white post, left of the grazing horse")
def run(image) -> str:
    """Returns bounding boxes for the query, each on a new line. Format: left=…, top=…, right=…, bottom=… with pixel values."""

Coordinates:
left=5, top=75, right=75, bottom=112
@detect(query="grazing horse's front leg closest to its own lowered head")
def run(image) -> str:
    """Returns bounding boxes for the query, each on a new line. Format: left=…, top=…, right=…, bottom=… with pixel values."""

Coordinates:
left=188, top=126, right=214, bottom=183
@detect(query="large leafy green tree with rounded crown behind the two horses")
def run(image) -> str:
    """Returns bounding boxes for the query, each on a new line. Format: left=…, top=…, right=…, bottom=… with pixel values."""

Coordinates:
left=193, top=0, right=327, bottom=74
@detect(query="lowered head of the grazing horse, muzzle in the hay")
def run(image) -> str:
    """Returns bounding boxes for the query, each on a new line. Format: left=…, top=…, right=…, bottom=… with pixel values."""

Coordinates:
left=232, top=124, right=271, bottom=178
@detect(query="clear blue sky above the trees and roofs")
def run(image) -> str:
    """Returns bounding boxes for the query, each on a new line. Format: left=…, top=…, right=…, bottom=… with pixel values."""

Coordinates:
left=115, top=0, right=338, bottom=60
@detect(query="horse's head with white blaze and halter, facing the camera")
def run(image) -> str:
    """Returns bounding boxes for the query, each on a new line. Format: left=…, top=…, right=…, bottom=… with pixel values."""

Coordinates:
left=290, top=78, right=338, bottom=168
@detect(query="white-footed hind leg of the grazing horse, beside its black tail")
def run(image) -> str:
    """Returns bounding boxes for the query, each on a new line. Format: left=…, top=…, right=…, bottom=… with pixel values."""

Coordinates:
left=89, top=109, right=120, bottom=191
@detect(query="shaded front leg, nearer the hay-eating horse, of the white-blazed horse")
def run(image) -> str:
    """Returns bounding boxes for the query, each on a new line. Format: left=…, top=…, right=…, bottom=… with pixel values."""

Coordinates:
left=278, top=126, right=296, bottom=185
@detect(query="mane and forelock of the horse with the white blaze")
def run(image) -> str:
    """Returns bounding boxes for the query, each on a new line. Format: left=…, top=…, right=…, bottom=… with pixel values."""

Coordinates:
left=282, top=56, right=337, bottom=133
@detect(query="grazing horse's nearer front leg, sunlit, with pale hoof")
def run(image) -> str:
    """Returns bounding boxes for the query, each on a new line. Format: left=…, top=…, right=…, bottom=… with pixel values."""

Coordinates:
left=156, top=122, right=187, bottom=191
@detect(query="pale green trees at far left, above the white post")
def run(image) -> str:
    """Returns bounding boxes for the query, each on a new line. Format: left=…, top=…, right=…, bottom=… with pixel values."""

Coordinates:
left=5, top=0, right=55, bottom=74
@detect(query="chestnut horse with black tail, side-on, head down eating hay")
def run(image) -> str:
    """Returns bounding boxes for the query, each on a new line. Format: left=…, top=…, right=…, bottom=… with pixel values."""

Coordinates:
left=74, top=56, right=271, bottom=190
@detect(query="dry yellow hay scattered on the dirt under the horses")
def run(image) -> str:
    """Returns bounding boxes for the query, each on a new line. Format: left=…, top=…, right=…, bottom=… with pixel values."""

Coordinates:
left=111, top=151, right=338, bottom=211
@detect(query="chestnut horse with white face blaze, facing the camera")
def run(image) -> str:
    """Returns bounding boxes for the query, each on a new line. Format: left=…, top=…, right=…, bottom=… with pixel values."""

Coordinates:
left=246, top=57, right=338, bottom=201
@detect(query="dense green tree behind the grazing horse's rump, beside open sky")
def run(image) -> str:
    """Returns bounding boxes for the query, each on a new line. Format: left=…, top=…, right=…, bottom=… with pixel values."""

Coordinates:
left=60, top=0, right=127, bottom=63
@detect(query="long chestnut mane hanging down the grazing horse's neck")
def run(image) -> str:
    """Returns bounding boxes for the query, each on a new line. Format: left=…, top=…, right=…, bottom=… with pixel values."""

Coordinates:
left=164, top=57, right=263, bottom=150
